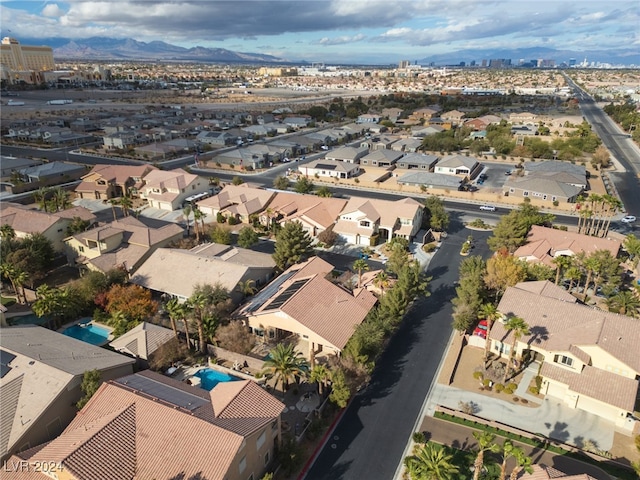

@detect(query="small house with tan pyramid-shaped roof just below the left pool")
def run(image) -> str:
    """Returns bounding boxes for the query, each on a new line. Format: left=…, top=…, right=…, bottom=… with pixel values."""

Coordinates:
left=109, top=322, right=176, bottom=370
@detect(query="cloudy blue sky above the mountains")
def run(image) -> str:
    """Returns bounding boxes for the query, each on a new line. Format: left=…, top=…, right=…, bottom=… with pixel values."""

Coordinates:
left=0, top=0, right=640, bottom=63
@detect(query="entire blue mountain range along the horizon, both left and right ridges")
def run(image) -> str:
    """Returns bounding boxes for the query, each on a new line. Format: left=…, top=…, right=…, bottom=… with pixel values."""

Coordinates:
left=20, top=37, right=640, bottom=66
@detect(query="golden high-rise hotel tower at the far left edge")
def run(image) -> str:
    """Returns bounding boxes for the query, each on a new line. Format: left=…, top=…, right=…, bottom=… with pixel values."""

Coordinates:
left=0, top=37, right=55, bottom=84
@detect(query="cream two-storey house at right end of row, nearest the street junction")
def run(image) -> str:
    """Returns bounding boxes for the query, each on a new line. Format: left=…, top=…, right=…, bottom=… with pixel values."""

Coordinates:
left=333, top=197, right=424, bottom=246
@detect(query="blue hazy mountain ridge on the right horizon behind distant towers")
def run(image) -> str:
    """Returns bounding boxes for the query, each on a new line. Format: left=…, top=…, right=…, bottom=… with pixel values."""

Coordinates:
left=418, top=47, right=640, bottom=65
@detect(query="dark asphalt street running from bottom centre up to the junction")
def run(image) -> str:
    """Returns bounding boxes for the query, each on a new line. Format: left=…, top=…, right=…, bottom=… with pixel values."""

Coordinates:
left=304, top=220, right=489, bottom=480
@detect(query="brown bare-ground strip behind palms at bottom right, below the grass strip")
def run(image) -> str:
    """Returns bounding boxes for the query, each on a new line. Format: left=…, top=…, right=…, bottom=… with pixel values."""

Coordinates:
left=420, top=416, right=611, bottom=480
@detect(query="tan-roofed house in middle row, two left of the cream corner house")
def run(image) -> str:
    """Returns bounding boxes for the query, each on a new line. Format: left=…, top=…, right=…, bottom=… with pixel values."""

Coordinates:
left=197, top=183, right=275, bottom=223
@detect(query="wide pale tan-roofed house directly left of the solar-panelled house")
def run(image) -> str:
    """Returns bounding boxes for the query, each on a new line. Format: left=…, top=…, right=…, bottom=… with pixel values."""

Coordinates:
left=130, top=243, right=275, bottom=302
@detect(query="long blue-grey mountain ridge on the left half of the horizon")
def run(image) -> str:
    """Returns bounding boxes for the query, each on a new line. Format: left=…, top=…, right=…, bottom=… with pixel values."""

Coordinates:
left=20, top=37, right=288, bottom=63
